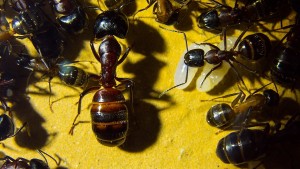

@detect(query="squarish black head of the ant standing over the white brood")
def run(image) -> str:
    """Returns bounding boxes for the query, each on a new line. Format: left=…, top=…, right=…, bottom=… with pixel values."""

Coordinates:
left=184, top=49, right=204, bottom=67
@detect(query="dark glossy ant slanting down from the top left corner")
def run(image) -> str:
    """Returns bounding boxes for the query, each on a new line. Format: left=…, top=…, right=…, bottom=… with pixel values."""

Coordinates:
left=9, top=0, right=64, bottom=67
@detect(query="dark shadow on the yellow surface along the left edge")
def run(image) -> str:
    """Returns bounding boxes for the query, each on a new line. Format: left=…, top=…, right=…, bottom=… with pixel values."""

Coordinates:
left=1, top=42, right=49, bottom=149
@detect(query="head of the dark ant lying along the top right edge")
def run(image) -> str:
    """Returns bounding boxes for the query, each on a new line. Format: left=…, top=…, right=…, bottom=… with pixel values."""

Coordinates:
left=197, top=10, right=219, bottom=29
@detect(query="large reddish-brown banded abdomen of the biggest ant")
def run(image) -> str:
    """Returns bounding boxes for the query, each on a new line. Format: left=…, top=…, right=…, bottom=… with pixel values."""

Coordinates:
left=91, top=88, right=128, bottom=147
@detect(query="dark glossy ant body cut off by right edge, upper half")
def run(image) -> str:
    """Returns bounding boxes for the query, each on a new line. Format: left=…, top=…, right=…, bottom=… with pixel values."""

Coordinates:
left=271, top=16, right=300, bottom=85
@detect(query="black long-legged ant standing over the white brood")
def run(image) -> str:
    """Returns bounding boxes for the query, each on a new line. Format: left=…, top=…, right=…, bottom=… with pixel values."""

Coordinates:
left=159, top=27, right=271, bottom=97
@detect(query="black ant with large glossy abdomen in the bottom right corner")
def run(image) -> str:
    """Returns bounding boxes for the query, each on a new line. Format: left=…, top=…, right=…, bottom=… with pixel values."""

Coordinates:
left=216, top=114, right=300, bottom=165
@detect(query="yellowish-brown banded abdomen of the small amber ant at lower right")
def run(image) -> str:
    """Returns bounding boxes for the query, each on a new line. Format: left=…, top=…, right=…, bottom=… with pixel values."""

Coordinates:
left=206, top=103, right=235, bottom=128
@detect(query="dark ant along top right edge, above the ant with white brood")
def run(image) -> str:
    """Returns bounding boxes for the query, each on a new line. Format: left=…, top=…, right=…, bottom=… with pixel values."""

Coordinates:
left=197, top=0, right=287, bottom=32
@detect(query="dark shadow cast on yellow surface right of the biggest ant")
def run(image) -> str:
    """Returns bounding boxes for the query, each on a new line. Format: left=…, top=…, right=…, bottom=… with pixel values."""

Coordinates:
left=120, top=21, right=172, bottom=152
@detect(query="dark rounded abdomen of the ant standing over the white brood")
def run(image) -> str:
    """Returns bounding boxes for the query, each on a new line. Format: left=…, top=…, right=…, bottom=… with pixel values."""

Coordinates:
left=238, top=33, right=271, bottom=60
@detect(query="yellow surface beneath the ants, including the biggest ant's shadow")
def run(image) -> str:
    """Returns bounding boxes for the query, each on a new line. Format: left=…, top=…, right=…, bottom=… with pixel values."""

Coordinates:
left=1, top=0, right=299, bottom=169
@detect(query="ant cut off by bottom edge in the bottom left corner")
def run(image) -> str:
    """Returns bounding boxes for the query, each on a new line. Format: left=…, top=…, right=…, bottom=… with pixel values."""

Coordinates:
left=0, top=150, right=59, bottom=169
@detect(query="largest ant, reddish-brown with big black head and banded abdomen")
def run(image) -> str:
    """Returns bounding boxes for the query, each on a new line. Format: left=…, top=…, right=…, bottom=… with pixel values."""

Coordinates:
left=69, top=2, right=134, bottom=146
